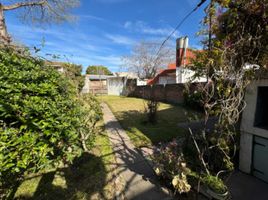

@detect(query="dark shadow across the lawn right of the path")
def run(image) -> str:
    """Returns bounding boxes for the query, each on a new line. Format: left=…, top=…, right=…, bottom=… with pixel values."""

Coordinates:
left=116, top=106, right=194, bottom=147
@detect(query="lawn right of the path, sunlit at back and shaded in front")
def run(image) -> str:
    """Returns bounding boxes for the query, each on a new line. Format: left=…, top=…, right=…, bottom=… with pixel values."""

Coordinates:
left=98, top=96, right=201, bottom=147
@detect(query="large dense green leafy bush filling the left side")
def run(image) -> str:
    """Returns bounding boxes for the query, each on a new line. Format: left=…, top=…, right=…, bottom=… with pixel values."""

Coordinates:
left=0, top=49, right=101, bottom=198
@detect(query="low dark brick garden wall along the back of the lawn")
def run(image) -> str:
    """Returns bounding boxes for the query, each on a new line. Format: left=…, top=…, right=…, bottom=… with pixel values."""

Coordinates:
left=130, top=83, right=200, bottom=104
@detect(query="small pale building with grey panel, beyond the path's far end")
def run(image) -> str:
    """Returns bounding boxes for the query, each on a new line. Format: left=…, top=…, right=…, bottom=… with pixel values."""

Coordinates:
left=82, top=74, right=113, bottom=94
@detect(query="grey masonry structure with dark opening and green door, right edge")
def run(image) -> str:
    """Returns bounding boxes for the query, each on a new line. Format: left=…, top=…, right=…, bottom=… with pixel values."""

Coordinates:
left=239, top=76, right=268, bottom=182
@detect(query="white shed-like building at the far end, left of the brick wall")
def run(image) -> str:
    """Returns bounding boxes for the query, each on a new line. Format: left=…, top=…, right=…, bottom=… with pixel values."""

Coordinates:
left=107, top=72, right=138, bottom=96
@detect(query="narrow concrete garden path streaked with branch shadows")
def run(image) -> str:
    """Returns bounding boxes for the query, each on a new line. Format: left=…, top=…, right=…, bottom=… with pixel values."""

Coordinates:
left=102, top=103, right=172, bottom=200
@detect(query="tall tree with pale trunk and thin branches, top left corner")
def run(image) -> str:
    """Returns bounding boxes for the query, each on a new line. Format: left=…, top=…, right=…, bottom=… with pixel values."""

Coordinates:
left=0, top=0, right=79, bottom=44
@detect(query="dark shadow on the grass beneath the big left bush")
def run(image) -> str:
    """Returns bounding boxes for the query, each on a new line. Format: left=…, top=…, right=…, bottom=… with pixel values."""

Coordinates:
left=16, top=153, right=107, bottom=200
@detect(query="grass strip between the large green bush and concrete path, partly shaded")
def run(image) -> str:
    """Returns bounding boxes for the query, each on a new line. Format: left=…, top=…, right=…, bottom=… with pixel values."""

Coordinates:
left=15, top=133, right=115, bottom=200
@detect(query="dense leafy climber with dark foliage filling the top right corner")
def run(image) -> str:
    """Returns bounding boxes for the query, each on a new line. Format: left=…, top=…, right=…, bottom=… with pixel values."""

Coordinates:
left=195, top=0, right=268, bottom=76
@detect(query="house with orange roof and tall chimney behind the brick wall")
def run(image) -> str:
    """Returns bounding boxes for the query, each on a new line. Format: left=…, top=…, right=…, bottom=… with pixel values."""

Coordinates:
left=148, top=37, right=207, bottom=85
